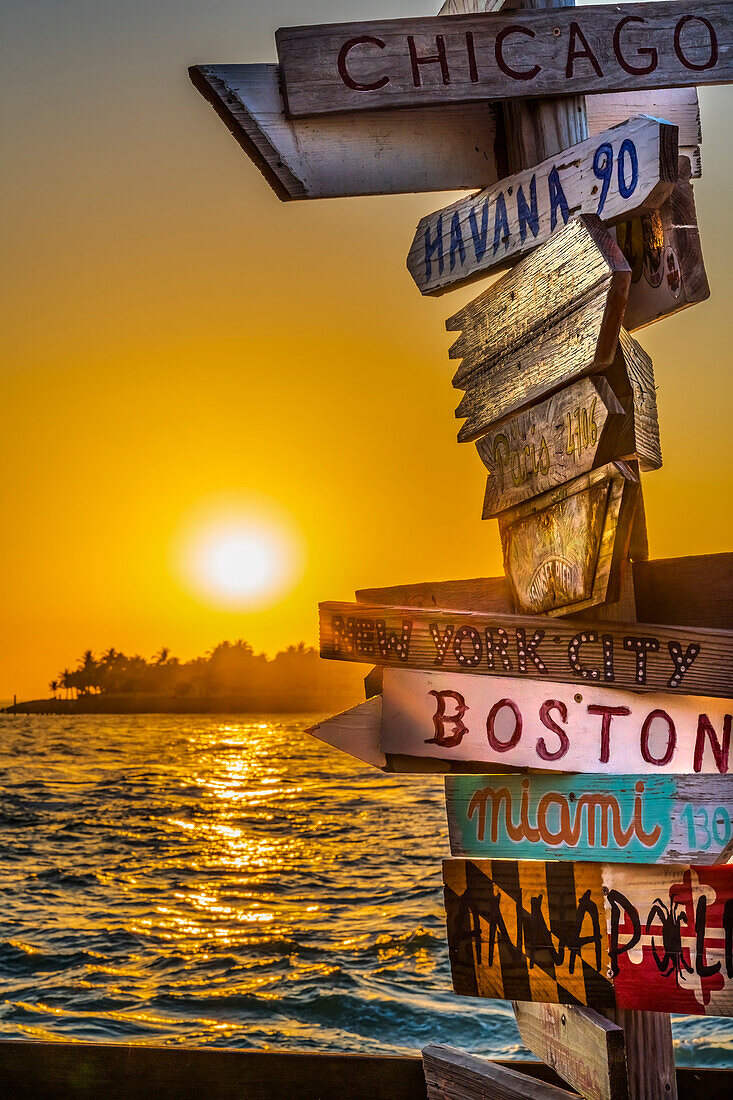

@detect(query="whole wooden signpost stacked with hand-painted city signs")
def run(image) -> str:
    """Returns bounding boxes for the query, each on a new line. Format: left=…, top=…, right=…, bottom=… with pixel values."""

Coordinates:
left=190, top=0, right=733, bottom=1100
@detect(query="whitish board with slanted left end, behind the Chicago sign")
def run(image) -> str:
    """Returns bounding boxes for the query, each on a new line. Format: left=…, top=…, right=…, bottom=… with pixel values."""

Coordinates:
left=188, top=65, right=702, bottom=201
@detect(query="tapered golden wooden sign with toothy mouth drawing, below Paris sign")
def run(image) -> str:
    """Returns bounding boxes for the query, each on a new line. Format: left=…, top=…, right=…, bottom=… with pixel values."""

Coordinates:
left=499, top=463, right=638, bottom=615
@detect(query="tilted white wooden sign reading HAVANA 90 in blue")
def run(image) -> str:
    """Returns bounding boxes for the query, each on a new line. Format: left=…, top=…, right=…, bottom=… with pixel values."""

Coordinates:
left=407, top=117, right=678, bottom=294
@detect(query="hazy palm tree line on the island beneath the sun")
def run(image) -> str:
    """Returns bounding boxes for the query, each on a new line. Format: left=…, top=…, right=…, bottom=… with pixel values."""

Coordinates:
left=48, top=638, right=363, bottom=702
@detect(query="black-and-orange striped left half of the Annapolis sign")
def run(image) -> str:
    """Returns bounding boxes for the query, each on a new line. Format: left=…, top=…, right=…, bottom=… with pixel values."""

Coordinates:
left=442, top=859, right=615, bottom=1008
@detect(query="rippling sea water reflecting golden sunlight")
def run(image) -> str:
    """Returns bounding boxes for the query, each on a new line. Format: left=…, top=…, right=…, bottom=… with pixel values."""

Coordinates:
left=0, top=715, right=733, bottom=1066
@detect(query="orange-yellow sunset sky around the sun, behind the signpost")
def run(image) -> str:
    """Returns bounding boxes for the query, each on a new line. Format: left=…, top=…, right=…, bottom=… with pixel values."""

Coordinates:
left=0, top=0, right=733, bottom=699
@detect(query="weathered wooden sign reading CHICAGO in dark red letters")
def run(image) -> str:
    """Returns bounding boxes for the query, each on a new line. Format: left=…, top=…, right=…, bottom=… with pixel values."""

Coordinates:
left=275, top=0, right=733, bottom=118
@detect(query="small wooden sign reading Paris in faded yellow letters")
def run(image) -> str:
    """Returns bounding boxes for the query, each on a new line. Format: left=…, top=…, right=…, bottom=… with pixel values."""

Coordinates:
left=475, top=375, right=625, bottom=519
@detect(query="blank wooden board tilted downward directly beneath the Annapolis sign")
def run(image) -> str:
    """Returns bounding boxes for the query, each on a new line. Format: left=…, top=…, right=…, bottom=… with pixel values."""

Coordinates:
left=512, top=1001, right=628, bottom=1100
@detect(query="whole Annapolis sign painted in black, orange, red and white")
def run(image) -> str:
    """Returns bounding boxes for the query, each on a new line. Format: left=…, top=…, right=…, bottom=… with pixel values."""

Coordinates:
left=442, top=859, right=733, bottom=1016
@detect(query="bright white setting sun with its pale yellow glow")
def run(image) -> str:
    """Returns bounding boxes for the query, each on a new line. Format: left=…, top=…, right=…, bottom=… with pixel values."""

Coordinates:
left=176, top=502, right=302, bottom=609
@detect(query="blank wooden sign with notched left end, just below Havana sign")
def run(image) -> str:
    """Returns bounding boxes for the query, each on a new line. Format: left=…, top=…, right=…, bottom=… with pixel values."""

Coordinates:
left=446, top=215, right=631, bottom=442
